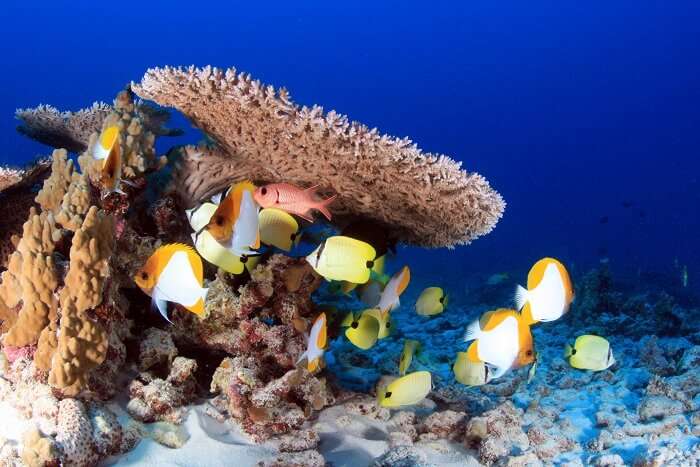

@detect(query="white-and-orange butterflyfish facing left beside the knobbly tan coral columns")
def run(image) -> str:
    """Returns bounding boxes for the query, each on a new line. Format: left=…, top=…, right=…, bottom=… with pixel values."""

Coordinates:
left=134, top=243, right=209, bottom=321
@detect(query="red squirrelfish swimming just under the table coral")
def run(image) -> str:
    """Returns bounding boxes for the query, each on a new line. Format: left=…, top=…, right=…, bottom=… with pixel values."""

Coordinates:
left=253, top=183, right=338, bottom=222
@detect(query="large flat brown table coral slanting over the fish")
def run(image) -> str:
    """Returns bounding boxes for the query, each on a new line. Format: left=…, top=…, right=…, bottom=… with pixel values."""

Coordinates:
left=132, top=67, right=505, bottom=247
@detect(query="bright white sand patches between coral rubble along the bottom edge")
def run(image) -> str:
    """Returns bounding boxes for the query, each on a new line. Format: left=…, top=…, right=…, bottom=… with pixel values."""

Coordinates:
left=0, top=402, right=478, bottom=467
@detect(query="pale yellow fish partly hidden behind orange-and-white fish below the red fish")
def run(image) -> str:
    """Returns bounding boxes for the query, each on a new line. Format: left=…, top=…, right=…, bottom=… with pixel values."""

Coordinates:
left=186, top=203, right=259, bottom=274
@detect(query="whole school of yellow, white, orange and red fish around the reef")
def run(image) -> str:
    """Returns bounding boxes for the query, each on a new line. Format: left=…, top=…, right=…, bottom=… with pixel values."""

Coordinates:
left=93, top=125, right=615, bottom=408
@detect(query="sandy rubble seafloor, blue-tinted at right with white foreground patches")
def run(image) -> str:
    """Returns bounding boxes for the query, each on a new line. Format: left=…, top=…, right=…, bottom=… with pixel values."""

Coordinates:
left=0, top=260, right=700, bottom=467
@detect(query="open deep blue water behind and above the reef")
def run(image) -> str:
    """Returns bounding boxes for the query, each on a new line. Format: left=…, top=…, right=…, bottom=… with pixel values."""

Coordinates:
left=0, top=0, right=700, bottom=285
